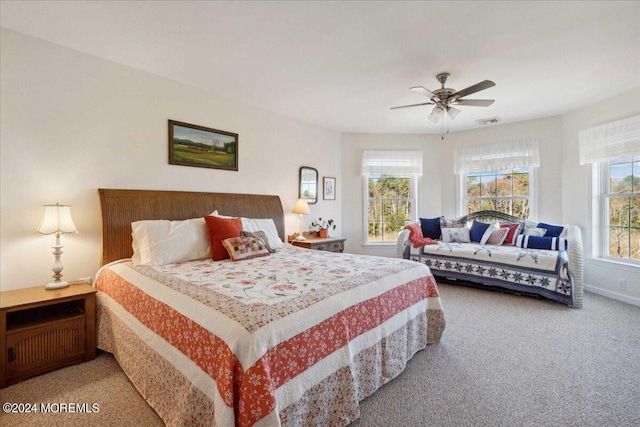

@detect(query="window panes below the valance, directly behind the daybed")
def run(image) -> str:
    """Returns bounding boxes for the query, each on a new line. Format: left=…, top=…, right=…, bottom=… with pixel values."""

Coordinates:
left=463, top=167, right=530, bottom=219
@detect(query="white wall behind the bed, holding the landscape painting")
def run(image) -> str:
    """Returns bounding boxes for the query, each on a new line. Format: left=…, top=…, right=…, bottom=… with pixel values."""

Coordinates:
left=0, top=29, right=343, bottom=290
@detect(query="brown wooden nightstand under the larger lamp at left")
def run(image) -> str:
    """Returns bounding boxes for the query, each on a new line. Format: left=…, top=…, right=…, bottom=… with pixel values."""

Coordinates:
left=0, top=282, right=96, bottom=388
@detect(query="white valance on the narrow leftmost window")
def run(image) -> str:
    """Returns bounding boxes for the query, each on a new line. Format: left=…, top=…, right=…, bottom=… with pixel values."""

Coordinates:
left=362, top=150, right=422, bottom=176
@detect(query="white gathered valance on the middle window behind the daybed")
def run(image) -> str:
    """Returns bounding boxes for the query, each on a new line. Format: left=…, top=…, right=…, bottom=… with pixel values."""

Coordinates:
left=453, top=139, right=540, bottom=175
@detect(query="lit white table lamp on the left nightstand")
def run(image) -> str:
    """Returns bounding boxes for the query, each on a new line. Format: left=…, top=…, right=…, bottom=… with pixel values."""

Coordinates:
left=37, top=203, right=78, bottom=289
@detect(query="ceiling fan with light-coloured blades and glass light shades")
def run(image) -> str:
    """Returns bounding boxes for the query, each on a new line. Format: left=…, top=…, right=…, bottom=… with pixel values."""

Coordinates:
left=391, top=73, right=496, bottom=123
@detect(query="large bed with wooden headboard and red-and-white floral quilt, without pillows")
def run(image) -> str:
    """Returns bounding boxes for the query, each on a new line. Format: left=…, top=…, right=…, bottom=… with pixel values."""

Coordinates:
left=95, top=189, right=445, bottom=426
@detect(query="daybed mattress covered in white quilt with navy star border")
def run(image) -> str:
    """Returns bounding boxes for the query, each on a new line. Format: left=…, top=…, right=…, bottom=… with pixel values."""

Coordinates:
left=409, top=242, right=574, bottom=305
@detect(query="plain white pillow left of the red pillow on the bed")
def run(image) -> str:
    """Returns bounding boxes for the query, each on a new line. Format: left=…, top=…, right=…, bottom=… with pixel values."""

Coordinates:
left=131, top=218, right=211, bottom=265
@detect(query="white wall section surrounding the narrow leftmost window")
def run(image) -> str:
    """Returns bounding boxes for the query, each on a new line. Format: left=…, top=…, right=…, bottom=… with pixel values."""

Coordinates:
left=342, top=133, right=442, bottom=257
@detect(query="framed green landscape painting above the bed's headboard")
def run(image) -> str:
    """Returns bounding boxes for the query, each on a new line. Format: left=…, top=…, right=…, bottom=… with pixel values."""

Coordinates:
left=169, top=120, right=238, bottom=171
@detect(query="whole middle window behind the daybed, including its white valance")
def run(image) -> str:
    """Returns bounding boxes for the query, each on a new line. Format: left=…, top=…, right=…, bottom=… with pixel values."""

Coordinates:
left=454, top=139, right=540, bottom=219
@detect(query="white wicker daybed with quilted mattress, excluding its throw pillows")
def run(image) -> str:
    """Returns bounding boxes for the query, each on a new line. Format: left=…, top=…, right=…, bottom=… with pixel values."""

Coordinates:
left=397, top=211, right=583, bottom=308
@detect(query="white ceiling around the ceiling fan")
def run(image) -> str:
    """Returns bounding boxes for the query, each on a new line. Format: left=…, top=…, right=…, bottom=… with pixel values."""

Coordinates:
left=0, top=0, right=640, bottom=133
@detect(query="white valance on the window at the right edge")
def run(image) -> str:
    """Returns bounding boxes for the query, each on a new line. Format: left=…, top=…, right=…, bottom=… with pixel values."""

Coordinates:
left=578, top=115, right=640, bottom=165
